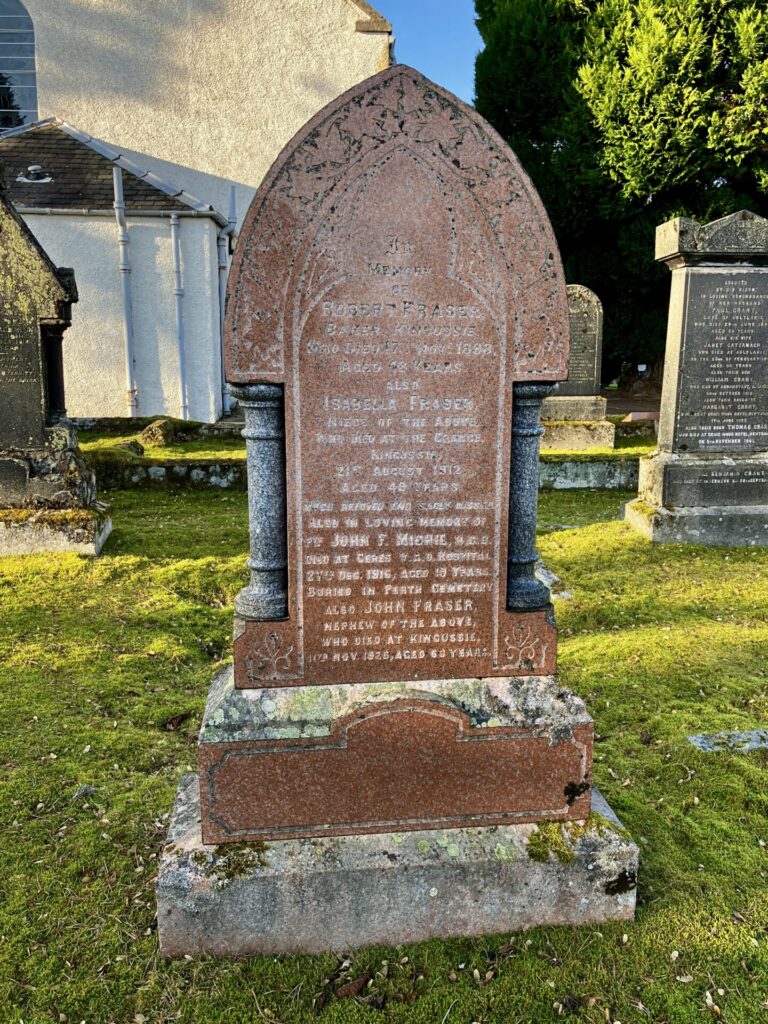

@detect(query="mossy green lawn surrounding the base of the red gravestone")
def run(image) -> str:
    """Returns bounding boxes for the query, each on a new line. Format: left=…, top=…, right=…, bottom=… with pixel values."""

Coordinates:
left=0, top=489, right=768, bottom=1024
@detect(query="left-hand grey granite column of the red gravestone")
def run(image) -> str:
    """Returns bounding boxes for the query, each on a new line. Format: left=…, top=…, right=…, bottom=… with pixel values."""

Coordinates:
left=230, top=384, right=288, bottom=621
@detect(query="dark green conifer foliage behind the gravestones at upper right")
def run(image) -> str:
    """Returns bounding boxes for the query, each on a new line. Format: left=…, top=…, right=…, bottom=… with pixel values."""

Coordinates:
left=475, top=0, right=768, bottom=375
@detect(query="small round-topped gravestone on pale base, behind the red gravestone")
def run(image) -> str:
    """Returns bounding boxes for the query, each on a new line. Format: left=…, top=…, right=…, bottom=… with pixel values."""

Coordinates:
left=542, top=285, right=615, bottom=452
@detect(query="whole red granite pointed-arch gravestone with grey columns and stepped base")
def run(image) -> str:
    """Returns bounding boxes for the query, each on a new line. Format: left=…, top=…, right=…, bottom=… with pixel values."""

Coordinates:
left=158, top=67, right=637, bottom=955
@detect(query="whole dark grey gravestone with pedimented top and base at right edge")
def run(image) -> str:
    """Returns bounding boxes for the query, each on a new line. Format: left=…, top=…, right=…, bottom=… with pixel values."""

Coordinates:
left=626, top=211, right=768, bottom=546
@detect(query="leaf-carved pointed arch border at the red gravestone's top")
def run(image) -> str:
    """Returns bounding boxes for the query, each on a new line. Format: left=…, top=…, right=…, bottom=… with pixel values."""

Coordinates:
left=225, top=66, right=566, bottom=383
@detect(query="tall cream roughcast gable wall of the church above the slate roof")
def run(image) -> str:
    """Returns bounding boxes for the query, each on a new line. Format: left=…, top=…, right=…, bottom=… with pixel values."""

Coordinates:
left=26, top=0, right=389, bottom=222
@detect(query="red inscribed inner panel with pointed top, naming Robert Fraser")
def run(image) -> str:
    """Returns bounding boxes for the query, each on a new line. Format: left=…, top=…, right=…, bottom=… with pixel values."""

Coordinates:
left=294, top=144, right=510, bottom=681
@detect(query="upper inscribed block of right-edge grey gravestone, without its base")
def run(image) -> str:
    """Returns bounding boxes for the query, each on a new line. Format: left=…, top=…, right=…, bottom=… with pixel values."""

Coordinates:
left=656, top=212, right=768, bottom=455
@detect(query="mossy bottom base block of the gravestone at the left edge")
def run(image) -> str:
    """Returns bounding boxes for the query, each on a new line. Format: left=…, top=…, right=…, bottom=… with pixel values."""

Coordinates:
left=0, top=503, right=112, bottom=557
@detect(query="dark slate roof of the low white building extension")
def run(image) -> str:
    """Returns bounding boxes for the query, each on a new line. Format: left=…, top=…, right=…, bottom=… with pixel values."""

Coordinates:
left=0, top=118, right=226, bottom=224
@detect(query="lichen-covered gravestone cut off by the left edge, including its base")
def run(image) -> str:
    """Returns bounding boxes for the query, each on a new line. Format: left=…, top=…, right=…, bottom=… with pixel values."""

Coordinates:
left=0, top=194, right=110, bottom=555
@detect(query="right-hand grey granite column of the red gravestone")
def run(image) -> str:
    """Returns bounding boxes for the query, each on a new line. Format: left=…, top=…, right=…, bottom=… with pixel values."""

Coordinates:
left=507, top=383, right=556, bottom=611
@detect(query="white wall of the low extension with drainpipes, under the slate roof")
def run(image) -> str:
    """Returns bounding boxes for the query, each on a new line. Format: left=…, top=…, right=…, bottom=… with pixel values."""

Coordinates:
left=25, top=212, right=221, bottom=422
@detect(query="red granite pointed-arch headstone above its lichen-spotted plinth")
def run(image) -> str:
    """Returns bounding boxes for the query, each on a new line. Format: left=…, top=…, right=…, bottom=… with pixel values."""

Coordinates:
left=225, top=67, right=568, bottom=686
